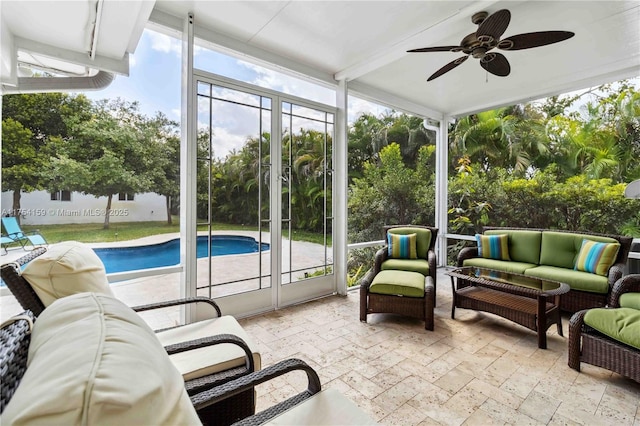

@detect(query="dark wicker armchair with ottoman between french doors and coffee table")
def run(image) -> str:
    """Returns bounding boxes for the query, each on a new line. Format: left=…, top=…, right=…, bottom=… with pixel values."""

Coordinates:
left=360, top=225, right=438, bottom=330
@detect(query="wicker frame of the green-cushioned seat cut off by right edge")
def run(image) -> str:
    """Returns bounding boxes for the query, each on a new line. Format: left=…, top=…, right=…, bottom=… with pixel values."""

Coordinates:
left=568, top=274, right=640, bottom=382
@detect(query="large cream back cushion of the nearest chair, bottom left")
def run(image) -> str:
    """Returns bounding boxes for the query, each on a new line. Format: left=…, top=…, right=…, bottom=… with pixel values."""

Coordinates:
left=1, top=293, right=200, bottom=425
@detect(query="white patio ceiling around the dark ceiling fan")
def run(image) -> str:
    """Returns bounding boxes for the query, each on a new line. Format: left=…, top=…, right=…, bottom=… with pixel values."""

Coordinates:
left=0, top=0, right=640, bottom=118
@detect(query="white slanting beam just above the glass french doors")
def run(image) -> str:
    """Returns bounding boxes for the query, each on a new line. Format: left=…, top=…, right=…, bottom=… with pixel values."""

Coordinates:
left=149, top=9, right=337, bottom=88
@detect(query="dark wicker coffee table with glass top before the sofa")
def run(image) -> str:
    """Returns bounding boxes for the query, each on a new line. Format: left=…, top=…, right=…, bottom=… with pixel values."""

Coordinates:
left=445, top=266, right=569, bottom=349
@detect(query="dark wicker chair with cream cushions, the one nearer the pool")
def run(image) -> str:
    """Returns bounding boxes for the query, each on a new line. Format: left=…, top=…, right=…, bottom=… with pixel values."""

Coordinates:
left=1, top=241, right=261, bottom=424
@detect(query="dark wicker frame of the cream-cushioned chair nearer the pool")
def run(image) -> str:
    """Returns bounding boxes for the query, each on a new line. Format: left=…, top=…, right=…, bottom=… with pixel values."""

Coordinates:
left=0, top=247, right=260, bottom=425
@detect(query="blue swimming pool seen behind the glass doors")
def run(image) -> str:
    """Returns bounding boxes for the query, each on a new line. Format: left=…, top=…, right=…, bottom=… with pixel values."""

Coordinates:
left=93, top=235, right=269, bottom=274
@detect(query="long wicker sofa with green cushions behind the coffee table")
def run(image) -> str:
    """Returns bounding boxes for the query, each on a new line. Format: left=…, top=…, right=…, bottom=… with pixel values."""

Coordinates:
left=457, top=227, right=632, bottom=312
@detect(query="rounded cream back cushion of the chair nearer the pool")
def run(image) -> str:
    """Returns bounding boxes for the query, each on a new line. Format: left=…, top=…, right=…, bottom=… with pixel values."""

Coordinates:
left=22, top=241, right=114, bottom=307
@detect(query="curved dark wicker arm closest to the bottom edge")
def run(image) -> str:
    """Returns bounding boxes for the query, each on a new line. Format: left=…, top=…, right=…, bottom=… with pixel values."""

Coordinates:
left=191, top=358, right=322, bottom=425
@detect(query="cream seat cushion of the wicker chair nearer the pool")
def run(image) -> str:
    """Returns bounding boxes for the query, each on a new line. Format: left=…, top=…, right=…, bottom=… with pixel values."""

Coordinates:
left=156, top=315, right=261, bottom=380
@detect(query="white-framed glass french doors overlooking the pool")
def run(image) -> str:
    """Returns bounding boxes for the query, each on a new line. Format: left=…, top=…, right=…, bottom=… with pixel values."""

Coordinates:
left=194, top=74, right=336, bottom=315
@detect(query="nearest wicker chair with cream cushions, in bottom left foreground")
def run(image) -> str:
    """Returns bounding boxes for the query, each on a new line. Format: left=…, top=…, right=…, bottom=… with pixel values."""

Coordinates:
left=0, top=293, right=376, bottom=425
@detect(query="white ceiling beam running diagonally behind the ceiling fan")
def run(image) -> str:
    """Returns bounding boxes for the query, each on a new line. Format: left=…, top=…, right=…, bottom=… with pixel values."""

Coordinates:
left=334, top=1, right=498, bottom=81
